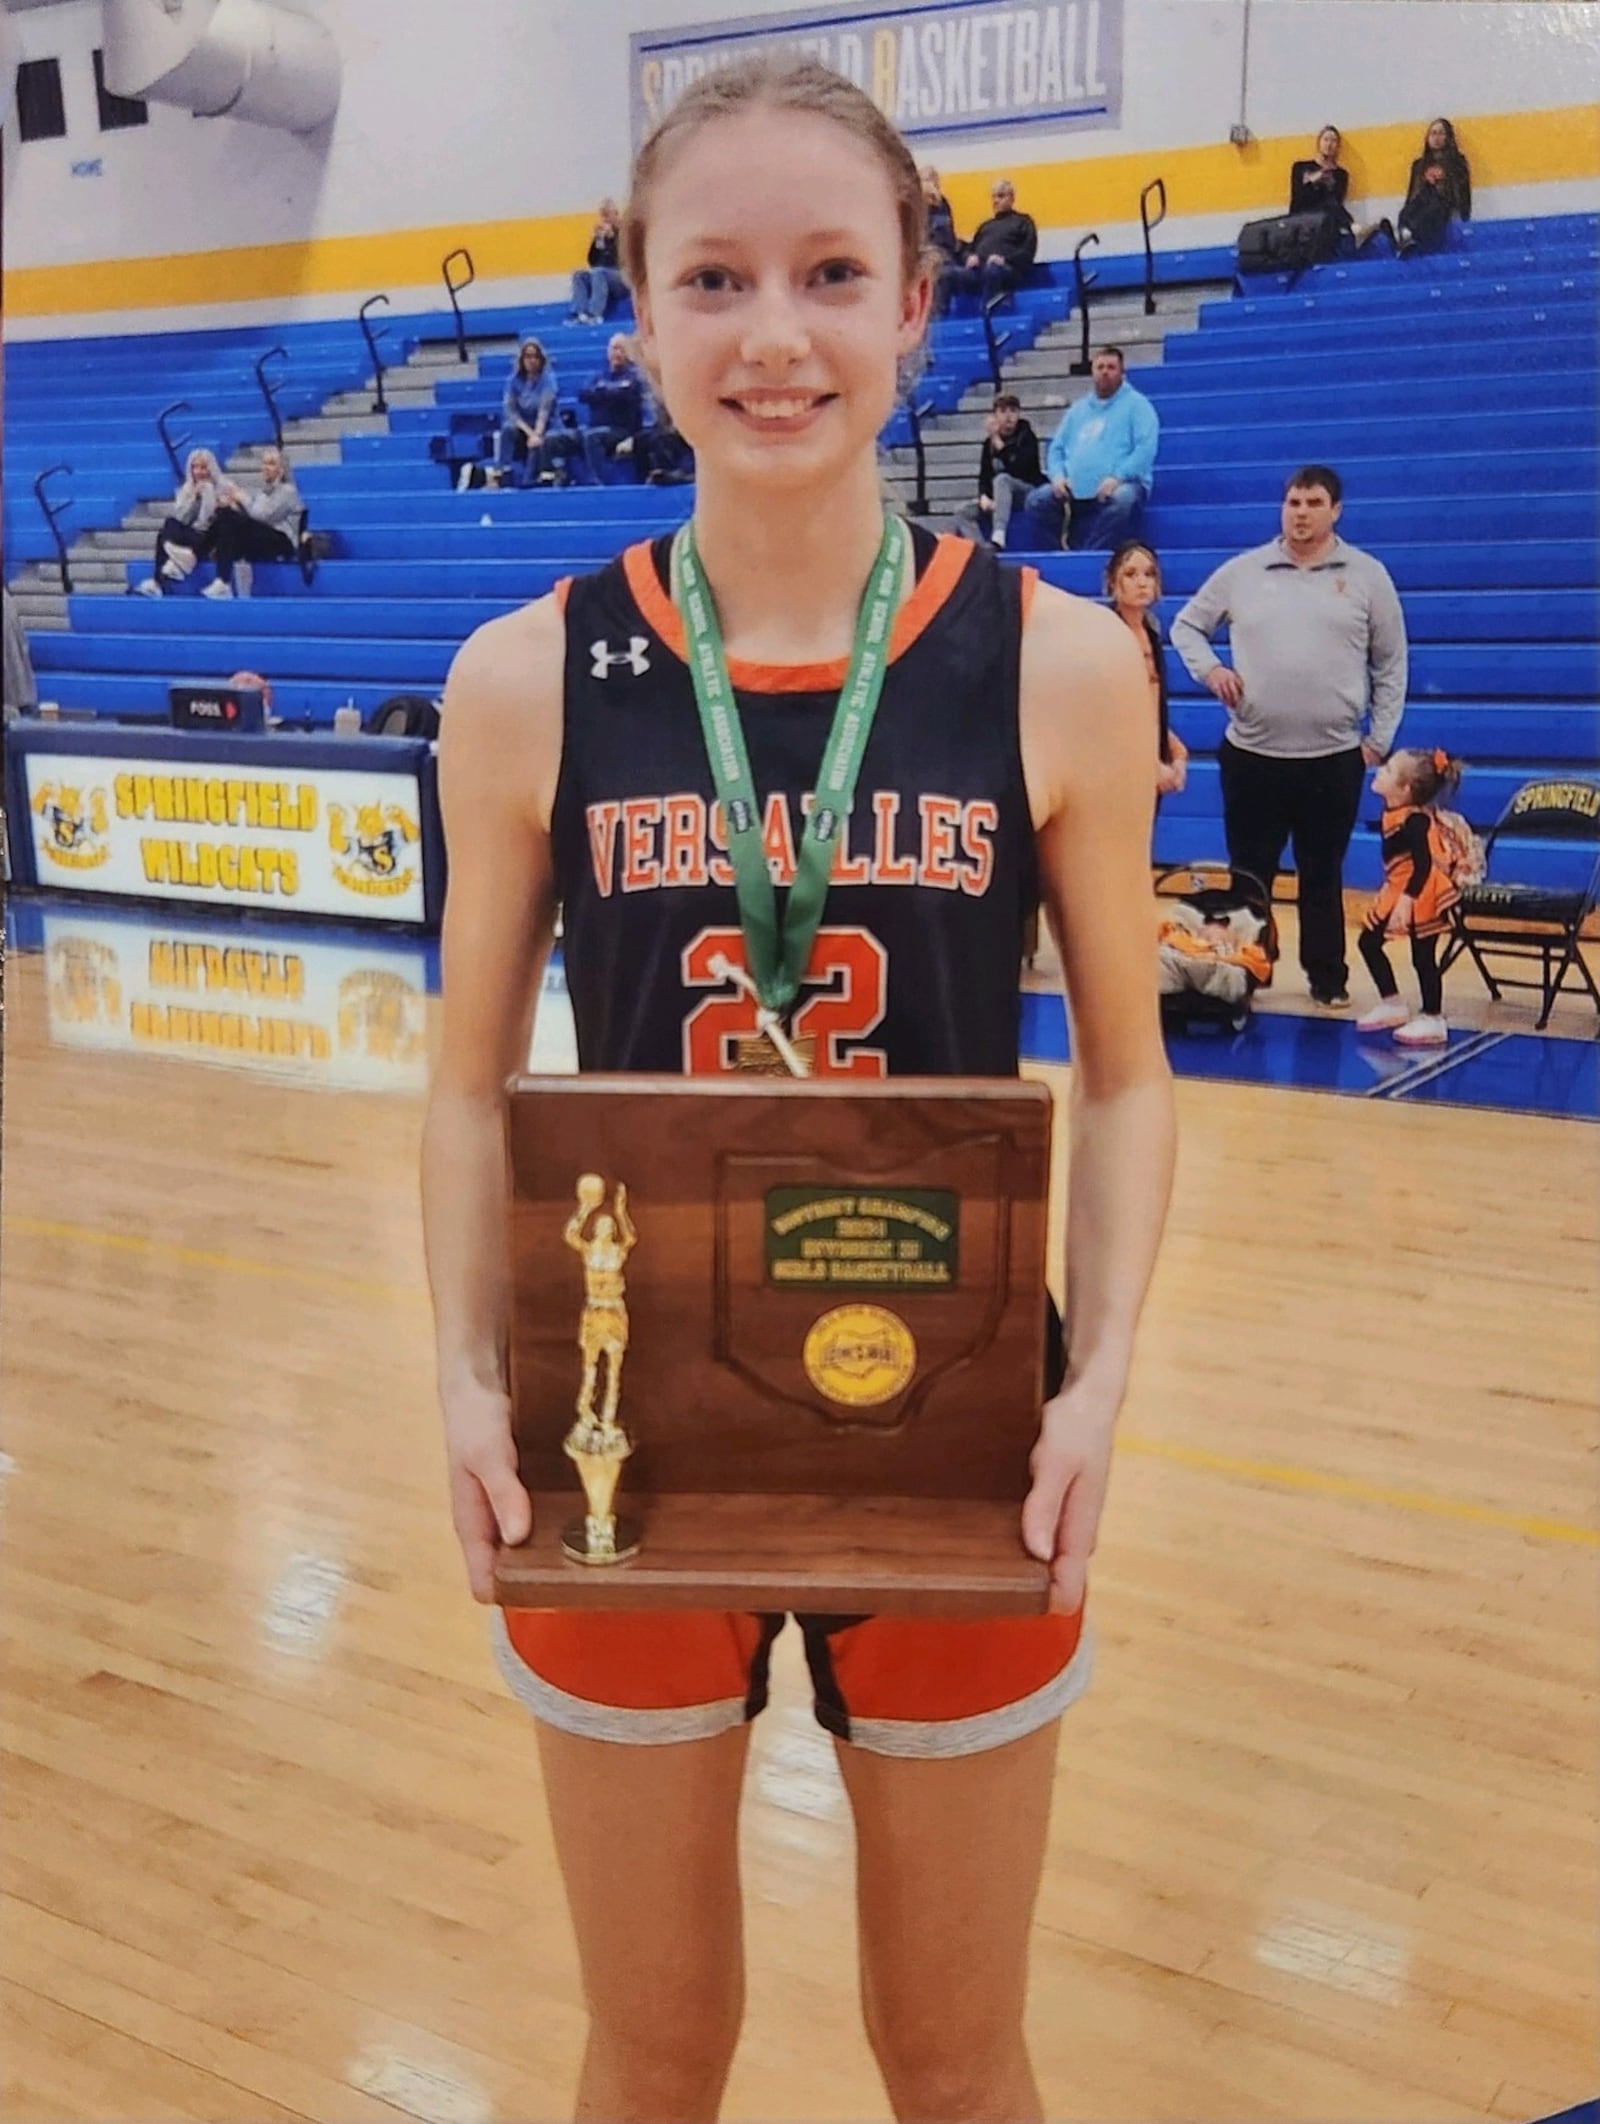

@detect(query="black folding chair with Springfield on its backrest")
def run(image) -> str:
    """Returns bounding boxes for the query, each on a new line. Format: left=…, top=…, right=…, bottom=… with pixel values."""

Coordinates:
left=1439, top=775, right=1600, bottom=1032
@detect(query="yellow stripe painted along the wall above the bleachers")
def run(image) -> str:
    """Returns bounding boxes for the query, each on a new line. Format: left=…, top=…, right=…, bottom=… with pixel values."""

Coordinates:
left=4, top=104, right=1600, bottom=316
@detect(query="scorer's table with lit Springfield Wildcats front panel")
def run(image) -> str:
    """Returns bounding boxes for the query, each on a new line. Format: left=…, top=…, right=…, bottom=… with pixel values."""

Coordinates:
left=6, top=722, right=444, bottom=930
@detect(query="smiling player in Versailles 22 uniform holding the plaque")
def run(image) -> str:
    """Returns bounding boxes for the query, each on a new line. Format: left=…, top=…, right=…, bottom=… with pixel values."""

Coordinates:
left=423, top=62, right=1173, bottom=2124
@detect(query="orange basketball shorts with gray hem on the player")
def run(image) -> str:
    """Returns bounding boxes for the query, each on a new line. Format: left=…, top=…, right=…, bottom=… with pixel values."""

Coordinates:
left=493, top=1608, right=1092, bottom=1759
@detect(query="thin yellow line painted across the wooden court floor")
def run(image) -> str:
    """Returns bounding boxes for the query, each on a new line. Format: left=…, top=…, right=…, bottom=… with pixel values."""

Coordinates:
left=4, top=1217, right=1600, bottom=1548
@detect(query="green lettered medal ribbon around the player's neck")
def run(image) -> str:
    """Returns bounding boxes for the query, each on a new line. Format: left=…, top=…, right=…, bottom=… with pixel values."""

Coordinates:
left=671, top=516, right=909, bottom=1026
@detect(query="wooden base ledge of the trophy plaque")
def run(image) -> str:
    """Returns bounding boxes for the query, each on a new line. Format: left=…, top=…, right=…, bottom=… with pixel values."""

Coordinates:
left=495, top=1491, right=1050, bottom=1621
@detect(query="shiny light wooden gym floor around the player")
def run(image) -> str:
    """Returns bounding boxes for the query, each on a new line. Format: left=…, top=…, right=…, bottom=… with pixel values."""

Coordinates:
left=0, top=934, right=1600, bottom=2124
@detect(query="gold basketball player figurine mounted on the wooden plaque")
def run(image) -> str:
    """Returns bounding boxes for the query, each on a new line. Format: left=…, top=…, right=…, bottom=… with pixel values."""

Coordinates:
left=561, top=1172, right=640, bottom=1563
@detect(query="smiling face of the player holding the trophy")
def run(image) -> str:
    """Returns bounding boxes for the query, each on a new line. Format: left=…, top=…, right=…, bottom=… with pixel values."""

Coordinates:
left=635, top=106, right=931, bottom=489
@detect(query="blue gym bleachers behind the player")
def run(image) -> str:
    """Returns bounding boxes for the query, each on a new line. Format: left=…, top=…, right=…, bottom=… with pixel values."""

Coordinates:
left=4, top=204, right=1600, bottom=913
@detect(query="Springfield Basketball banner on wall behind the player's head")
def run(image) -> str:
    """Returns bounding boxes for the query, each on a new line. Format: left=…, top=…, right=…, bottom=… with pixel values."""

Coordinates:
left=629, top=0, right=1122, bottom=144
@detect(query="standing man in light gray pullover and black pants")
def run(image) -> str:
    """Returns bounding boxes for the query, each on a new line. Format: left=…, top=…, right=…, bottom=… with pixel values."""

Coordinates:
left=1173, top=465, right=1407, bottom=1011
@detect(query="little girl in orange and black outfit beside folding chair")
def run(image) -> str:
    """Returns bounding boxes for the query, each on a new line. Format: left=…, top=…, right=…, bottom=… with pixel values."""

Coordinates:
left=1356, top=750, right=1462, bottom=1047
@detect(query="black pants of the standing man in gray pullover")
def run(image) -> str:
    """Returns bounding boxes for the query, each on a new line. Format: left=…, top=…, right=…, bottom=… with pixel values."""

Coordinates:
left=1218, top=737, right=1364, bottom=996
